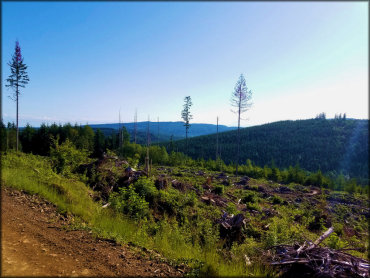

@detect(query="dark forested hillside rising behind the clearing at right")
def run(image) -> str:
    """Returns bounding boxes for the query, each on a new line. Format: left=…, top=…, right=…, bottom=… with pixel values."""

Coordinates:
left=163, top=118, right=369, bottom=182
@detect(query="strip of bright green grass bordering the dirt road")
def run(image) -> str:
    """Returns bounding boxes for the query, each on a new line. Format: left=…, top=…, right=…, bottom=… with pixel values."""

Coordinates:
left=2, top=152, right=273, bottom=277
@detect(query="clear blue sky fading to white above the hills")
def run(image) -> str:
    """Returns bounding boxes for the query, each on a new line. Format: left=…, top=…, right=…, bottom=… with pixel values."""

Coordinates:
left=2, top=2, right=369, bottom=126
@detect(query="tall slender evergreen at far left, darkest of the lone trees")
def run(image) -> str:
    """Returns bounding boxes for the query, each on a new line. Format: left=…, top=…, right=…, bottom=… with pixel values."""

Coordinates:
left=5, top=41, right=30, bottom=151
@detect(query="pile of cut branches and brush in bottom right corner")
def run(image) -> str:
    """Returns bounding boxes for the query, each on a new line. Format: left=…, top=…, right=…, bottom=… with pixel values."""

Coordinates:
left=268, top=227, right=370, bottom=278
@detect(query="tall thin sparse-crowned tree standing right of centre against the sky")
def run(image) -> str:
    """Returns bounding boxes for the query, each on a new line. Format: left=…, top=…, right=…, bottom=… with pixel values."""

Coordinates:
left=230, top=74, right=252, bottom=175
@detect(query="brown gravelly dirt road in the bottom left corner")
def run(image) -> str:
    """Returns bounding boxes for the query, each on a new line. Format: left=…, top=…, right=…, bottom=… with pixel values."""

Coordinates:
left=1, top=188, right=184, bottom=277
